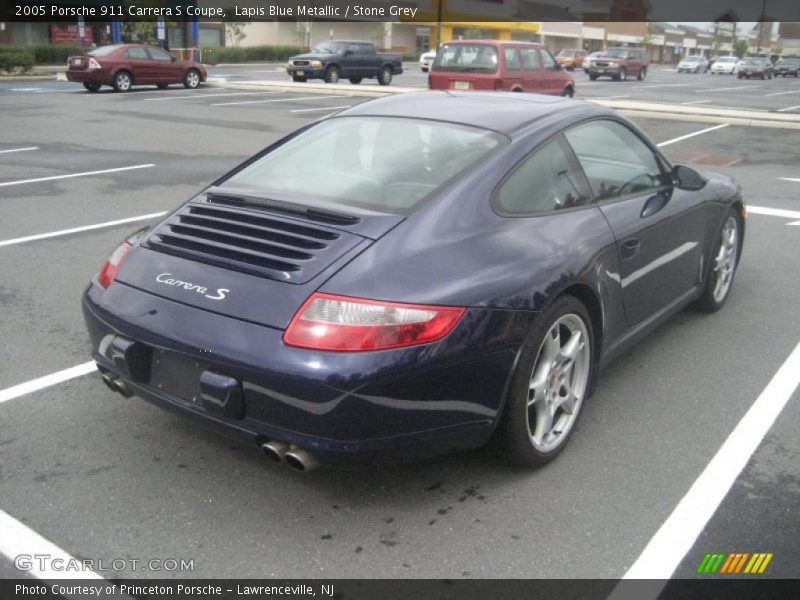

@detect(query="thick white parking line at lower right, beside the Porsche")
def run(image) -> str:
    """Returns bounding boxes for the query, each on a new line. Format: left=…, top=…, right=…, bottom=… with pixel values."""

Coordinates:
left=623, top=343, right=800, bottom=580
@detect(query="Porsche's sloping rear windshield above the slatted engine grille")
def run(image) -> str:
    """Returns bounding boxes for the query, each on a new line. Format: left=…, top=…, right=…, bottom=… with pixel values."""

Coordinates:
left=223, top=117, right=507, bottom=214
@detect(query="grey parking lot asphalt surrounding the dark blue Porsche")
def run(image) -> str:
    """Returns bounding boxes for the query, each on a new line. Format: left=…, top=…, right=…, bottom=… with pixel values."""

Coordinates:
left=0, top=81, right=800, bottom=578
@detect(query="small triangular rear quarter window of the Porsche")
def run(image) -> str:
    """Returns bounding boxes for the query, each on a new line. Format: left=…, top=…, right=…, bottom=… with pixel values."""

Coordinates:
left=496, top=136, right=590, bottom=215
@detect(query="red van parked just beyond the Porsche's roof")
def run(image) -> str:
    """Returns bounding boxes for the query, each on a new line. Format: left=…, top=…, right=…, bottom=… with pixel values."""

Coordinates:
left=428, top=40, right=575, bottom=96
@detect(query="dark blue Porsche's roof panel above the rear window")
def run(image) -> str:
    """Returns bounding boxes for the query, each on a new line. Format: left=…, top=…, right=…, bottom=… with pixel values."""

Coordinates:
left=336, top=90, right=614, bottom=135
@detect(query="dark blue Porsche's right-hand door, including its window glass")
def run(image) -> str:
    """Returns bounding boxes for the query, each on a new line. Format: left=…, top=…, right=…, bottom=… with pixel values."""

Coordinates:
left=565, top=119, right=708, bottom=326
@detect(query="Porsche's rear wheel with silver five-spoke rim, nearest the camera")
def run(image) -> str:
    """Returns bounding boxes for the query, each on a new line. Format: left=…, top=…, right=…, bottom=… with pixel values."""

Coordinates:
left=497, top=296, right=594, bottom=467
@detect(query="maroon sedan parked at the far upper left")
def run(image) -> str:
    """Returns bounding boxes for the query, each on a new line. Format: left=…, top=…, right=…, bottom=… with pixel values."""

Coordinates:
left=67, top=44, right=207, bottom=92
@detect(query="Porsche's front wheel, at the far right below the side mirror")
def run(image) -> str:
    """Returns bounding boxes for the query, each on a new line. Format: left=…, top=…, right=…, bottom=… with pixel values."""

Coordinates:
left=697, top=209, right=742, bottom=312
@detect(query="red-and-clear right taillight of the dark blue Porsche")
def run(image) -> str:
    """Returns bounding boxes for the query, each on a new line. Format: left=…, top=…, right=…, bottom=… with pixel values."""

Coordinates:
left=283, top=292, right=466, bottom=352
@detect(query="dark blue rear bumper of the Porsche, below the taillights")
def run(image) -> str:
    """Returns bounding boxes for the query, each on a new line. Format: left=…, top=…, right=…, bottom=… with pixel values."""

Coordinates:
left=83, top=283, right=532, bottom=462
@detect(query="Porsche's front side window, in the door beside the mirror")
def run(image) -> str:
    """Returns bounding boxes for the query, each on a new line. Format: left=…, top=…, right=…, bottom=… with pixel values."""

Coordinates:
left=564, top=120, right=662, bottom=201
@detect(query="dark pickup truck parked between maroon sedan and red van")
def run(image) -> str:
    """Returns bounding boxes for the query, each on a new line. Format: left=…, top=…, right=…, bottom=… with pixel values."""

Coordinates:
left=286, top=40, right=403, bottom=85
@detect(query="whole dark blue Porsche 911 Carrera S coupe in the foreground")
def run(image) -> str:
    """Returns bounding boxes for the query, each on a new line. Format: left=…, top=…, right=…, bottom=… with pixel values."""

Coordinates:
left=84, top=92, right=745, bottom=471
